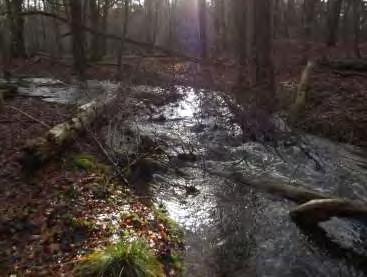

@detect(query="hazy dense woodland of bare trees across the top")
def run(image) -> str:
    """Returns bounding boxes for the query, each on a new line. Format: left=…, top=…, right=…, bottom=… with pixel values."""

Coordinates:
left=0, top=0, right=367, bottom=79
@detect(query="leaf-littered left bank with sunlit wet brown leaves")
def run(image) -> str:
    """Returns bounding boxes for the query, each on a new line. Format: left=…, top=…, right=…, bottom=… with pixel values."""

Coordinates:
left=0, top=93, right=182, bottom=276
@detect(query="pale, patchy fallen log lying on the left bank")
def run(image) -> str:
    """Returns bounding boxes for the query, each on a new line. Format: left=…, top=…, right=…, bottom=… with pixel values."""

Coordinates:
left=20, top=97, right=115, bottom=170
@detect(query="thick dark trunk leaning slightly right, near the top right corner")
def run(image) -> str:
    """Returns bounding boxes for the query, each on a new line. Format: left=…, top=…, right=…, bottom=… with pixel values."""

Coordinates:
left=326, top=0, right=343, bottom=46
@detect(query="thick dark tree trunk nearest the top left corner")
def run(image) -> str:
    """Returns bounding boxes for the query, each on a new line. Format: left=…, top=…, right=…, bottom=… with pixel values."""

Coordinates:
left=6, top=0, right=26, bottom=58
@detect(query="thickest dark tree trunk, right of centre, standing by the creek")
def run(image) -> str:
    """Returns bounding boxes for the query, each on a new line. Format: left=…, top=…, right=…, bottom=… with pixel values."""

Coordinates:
left=254, top=0, right=274, bottom=92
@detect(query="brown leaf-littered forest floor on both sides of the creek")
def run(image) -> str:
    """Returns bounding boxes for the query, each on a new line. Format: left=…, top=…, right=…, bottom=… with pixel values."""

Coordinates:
left=0, top=39, right=367, bottom=276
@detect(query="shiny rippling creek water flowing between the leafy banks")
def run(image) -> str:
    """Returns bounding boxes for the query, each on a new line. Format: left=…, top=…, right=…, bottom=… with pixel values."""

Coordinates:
left=17, top=77, right=367, bottom=277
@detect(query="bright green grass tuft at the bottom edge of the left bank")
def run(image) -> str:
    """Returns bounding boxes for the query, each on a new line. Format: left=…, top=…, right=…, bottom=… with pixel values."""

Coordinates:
left=74, top=239, right=165, bottom=277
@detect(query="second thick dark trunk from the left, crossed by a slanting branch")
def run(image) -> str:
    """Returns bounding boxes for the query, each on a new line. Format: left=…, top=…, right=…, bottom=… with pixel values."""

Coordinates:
left=69, top=0, right=86, bottom=77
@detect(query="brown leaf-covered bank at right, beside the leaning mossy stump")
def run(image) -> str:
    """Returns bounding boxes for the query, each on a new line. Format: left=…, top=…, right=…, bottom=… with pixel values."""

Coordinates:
left=296, top=67, right=367, bottom=146
